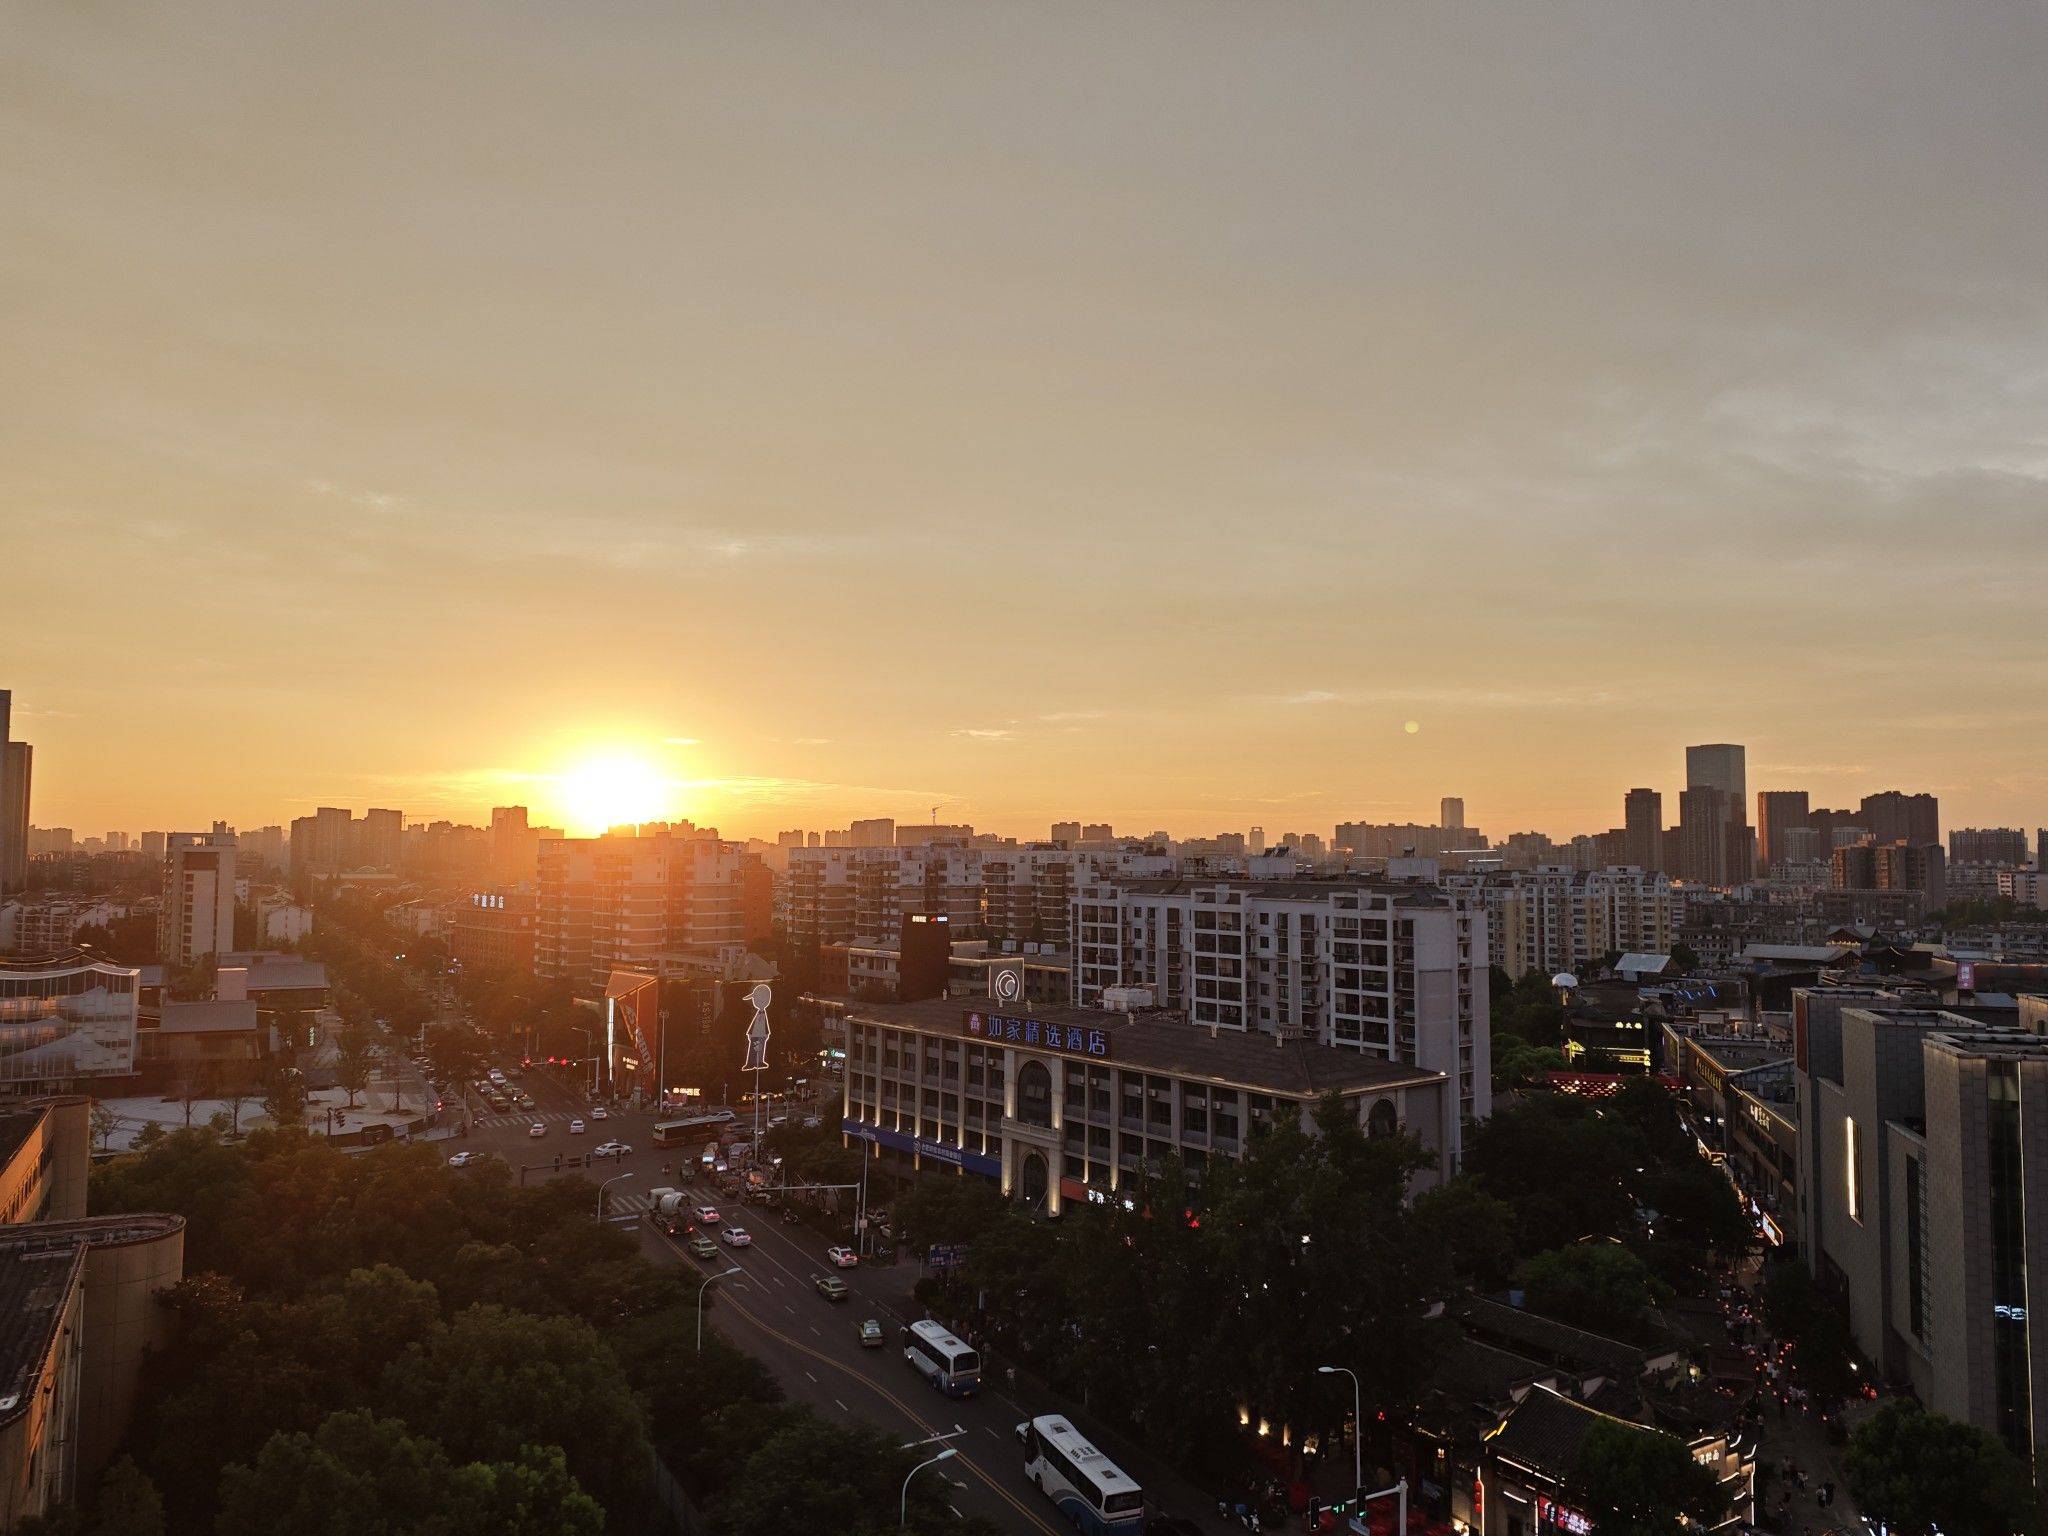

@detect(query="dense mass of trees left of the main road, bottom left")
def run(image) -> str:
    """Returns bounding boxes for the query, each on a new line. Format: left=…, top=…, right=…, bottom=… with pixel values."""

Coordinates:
left=20, top=1128, right=1007, bottom=1536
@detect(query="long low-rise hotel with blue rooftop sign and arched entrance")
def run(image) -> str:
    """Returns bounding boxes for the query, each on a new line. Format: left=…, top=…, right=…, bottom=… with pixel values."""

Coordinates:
left=840, top=999, right=1458, bottom=1212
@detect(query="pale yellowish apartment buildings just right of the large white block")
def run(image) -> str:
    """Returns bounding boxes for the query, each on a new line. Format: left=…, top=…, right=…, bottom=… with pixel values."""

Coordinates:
left=1444, top=864, right=1686, bottom=981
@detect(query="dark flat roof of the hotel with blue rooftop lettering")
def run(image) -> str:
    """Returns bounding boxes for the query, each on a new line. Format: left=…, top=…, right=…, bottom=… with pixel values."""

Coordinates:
left=846, top=997, right=1444, bottom=1098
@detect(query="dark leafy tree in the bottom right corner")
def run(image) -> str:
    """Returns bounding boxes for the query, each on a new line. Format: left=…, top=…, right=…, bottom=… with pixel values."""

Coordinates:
left=1843, top=1397, right=2040, bottom=1536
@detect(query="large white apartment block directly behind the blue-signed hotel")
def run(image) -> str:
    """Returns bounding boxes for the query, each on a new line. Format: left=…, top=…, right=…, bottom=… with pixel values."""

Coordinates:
left=1073, top=874, right=1493, bottom=1165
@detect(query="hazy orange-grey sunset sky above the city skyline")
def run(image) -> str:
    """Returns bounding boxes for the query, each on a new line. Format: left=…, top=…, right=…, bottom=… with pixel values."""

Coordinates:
left=0, top=0, right=2048, bottom=836
